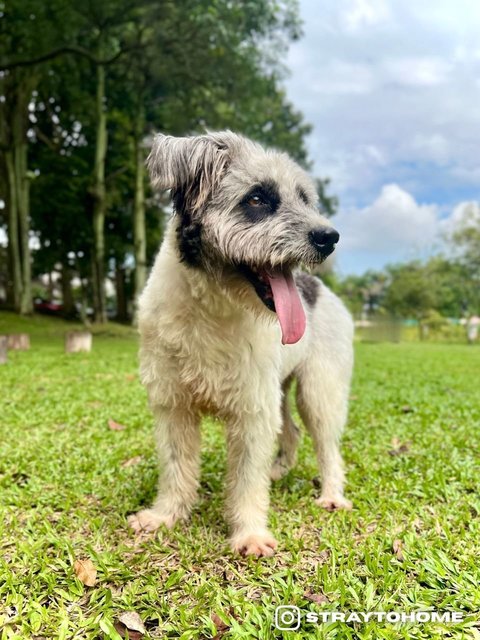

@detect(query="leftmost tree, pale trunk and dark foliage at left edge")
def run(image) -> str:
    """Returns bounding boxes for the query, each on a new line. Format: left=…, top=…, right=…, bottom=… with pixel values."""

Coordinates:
left=0, top=0, right=79, bottom=313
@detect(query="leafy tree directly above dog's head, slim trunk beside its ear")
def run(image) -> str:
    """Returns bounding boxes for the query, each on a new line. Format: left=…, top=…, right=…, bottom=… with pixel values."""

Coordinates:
left=114, top=0, right=309, bottom=308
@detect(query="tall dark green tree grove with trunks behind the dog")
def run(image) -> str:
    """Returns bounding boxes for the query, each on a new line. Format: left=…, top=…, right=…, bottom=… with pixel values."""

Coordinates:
left=0, top=0, right=320, bottom=321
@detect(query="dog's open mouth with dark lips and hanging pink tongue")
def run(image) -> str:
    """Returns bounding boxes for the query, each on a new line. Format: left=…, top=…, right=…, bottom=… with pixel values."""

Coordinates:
left=240, top=265, right=306, bottom=344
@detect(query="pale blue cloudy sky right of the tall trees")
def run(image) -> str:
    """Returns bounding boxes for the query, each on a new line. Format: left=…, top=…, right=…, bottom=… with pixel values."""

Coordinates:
left=286, top=0, right=480, bottom=275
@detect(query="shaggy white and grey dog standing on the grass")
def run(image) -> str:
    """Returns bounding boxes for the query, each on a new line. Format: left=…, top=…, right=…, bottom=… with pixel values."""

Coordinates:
left=129, top=131, right=353, bottom=556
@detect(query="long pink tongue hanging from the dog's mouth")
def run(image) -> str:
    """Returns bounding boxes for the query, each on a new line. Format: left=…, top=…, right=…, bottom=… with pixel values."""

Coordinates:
left=266, top=271, right=307, bottom=344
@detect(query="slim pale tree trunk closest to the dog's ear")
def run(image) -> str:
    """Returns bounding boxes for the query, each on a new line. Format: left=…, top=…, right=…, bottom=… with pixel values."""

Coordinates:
left=133, top=106, right=147, bottom=314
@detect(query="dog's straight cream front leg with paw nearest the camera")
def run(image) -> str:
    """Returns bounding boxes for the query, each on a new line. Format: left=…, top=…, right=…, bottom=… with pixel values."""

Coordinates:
left=227, top=410, right=280, bottom=556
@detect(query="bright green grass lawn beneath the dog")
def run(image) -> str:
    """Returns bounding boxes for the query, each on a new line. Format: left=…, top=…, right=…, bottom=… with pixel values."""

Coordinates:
left=0, top=314, right=480, bottom=640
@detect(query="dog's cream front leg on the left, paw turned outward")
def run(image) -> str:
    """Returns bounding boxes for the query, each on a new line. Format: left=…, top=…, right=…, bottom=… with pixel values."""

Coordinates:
left=128, top=407, right=200, bottom=532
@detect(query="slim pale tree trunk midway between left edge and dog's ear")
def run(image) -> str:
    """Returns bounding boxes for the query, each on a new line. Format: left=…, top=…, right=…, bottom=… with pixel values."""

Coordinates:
left=92, top=64, right=107, bottom=323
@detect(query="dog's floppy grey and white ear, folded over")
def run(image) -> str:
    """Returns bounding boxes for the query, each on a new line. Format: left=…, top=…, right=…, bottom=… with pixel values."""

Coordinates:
left=147, top=132, right=234, bottom=213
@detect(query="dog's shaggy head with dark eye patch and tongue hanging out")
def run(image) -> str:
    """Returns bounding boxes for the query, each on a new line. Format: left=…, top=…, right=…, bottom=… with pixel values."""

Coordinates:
left=147, top=131, right=339, bottom=344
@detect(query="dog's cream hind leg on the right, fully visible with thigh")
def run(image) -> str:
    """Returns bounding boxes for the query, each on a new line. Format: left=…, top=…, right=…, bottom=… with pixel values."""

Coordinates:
left=297, top=344, right=352, bottom=511
